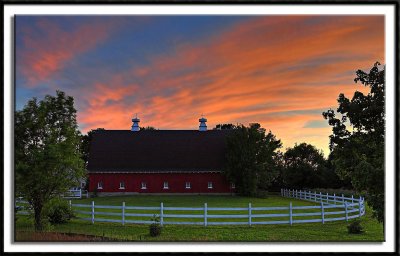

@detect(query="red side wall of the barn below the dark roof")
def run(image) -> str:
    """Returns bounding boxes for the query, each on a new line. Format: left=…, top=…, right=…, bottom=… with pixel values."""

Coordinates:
left=89, top=173, right=234, bottom=193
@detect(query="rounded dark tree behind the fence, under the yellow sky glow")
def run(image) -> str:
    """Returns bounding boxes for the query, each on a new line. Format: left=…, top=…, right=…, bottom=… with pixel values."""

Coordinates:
left=283, top=143, right=329, bottom=189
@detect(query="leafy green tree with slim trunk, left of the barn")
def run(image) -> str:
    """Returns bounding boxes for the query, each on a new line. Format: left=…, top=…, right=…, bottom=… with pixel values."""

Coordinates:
left=15, top=91, right=84, bottom=230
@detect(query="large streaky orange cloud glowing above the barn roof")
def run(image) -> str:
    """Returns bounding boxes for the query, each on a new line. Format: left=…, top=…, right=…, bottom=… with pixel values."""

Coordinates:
left=72, top=16, right=384, bottom=155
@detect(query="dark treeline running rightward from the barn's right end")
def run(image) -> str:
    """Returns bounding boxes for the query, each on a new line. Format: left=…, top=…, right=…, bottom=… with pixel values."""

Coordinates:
left=220, top=123, right=352, bottom=196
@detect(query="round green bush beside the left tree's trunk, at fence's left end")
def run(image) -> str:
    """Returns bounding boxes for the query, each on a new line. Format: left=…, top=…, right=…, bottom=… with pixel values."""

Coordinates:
left=42, top=198, right=74, bottom=225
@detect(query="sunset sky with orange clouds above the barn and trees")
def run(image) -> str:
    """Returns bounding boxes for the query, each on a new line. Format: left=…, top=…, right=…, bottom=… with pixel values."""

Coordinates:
left=15, top=15, right=385, bottom=156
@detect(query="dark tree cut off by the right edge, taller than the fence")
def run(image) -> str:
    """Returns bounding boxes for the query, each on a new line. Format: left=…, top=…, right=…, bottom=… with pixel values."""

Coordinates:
left=322, top=62, right=385, bottom=222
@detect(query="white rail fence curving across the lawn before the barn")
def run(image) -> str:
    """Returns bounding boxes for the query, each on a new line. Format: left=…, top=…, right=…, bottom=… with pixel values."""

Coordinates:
left=14, top=189, right=365, bottom=226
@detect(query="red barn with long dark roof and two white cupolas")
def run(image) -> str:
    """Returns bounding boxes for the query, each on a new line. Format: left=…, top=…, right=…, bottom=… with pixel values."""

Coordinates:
left=88, top=118, right=235, bottom=195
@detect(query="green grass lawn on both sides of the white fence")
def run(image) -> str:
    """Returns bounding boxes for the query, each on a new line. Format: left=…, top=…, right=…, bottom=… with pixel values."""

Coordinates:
left=16, top=195, right=384, bottom=242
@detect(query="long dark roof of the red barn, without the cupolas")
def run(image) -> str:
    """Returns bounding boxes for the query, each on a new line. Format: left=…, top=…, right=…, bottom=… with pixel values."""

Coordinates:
left=88, top=130, right=230, bottom=172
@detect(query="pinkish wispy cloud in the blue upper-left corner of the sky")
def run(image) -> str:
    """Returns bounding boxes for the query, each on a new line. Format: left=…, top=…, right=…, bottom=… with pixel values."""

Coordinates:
left=16, top=17, right=126, bottom=87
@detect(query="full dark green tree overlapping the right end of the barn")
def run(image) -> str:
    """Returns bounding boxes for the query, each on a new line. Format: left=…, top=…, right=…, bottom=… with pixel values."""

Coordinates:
left=225, top=124, right=282, bottom=196
